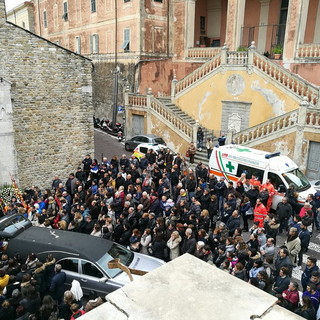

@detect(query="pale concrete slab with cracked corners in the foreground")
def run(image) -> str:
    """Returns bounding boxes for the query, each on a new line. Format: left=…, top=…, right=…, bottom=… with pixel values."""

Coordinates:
left=81, top=254, right=302, bottom=320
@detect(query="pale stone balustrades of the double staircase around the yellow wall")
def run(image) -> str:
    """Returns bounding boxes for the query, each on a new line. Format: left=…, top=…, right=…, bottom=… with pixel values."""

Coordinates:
left=125, top=44, right=320, bottom=163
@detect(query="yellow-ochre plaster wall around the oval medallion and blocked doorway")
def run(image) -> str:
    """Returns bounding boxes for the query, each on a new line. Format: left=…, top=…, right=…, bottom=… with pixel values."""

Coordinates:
left=176, top=71, right=299, bottom=130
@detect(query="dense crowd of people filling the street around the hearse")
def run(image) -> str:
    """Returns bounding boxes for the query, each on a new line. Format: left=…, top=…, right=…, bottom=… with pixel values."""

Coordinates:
left=0, top=149, right=320, bottom=320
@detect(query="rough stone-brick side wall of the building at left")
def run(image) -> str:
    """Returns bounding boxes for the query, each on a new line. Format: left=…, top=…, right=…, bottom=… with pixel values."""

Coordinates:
left=0, top=0, right=93, bottom=188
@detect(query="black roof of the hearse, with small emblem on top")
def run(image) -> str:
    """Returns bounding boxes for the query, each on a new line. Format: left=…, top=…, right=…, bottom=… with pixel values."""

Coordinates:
left=8, top=226, right=113, bottom=261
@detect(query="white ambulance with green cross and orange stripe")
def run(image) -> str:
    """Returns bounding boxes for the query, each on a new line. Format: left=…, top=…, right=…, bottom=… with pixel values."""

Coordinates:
left=209, top=144, right=316, bottom=209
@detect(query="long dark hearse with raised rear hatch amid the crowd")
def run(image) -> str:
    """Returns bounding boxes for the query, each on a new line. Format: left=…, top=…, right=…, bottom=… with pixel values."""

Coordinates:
left=0, top=215, right=165, bottom=296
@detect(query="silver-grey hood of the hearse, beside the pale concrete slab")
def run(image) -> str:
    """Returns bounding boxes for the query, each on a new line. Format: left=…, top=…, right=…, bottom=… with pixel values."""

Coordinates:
left=113, top=252, right=165, bottom=285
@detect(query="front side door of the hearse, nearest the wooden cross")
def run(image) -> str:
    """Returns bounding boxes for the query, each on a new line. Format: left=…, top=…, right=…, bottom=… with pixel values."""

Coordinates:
left=81, top=259, right=119, bottom=296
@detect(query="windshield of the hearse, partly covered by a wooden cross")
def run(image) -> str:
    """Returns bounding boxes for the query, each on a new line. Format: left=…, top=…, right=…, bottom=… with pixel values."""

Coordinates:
left=97, top=243, right=134, bottom=278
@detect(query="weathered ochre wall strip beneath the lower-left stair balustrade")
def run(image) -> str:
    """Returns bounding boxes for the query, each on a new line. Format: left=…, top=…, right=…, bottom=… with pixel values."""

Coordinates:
left=149, top=114, right=189, bottom=156
